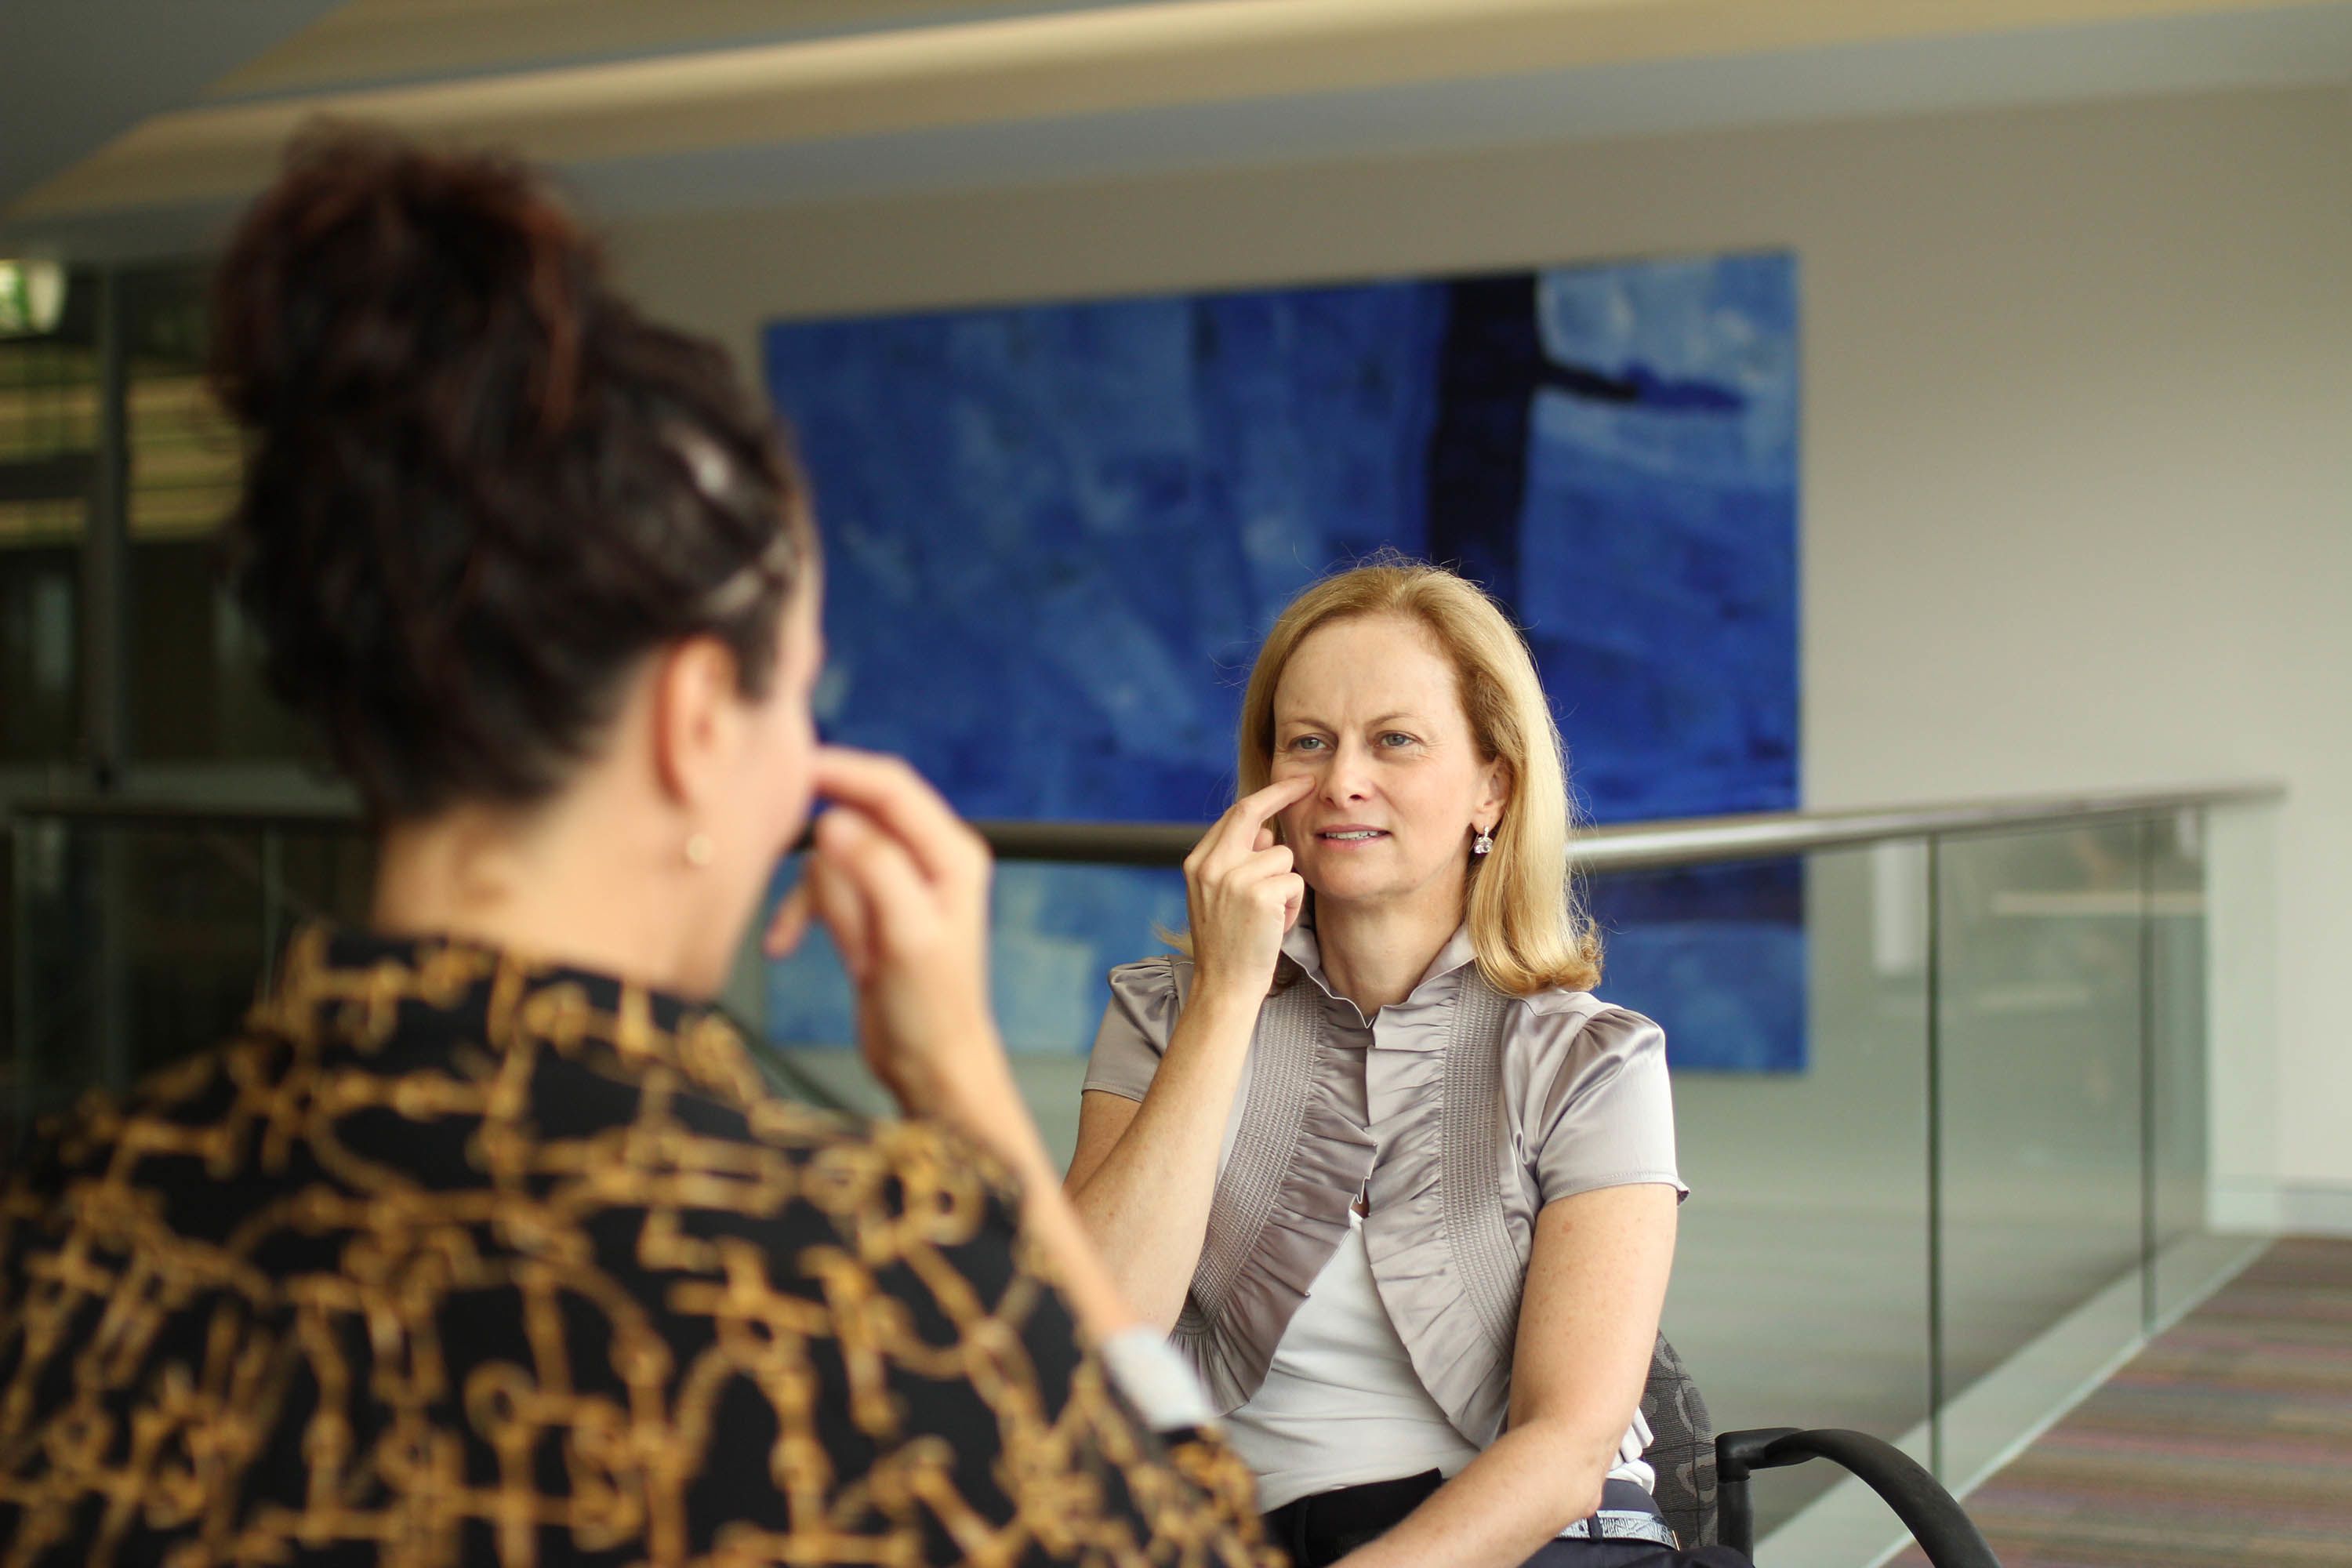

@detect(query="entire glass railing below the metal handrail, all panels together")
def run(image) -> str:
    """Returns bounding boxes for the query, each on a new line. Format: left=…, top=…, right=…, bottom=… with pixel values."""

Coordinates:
left=5, top=804, right=2277, bottom=1535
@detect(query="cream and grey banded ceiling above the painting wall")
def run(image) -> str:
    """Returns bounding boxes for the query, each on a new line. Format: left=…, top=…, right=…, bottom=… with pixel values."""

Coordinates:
left=13, top=0, right=2352, bottom=256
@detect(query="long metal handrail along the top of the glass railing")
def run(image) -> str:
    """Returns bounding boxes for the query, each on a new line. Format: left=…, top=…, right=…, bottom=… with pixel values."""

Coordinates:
left=7, top=781, right=2286, bottom=872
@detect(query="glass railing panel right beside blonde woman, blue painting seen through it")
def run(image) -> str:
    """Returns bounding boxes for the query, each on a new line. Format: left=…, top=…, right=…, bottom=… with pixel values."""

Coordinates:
left=1592, top=839, right=1929, bottom=1533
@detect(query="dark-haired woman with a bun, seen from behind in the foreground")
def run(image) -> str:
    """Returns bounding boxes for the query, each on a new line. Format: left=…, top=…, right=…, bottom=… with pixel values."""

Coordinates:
left=0, top=134, right=1258, bottom=1568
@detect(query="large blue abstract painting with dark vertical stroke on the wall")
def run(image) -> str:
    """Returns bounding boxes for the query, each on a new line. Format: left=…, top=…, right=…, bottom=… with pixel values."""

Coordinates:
left=764, top=252, right=1804, bottom=1069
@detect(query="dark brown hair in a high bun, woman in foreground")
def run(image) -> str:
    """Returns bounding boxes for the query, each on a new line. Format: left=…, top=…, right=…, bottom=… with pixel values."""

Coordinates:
left=212, top=129, right=809, bottom=815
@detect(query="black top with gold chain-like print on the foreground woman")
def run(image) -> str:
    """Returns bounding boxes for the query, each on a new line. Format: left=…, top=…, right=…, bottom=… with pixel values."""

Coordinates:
left=0, top=931, right=1279, bottom=1568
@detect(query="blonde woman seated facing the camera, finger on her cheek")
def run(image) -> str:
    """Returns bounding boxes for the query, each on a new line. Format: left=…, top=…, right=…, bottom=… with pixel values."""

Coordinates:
left=1068, top=562, right=1731, bottom=1568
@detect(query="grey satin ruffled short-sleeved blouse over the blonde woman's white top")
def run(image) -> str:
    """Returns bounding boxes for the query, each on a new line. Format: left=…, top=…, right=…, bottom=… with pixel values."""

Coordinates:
left=1084, top=924, right=1689, bottom=1448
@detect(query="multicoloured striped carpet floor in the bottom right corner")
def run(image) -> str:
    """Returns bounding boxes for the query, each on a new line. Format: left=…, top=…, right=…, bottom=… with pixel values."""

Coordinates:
left=1896, top=1239, right=2352, bottom=1568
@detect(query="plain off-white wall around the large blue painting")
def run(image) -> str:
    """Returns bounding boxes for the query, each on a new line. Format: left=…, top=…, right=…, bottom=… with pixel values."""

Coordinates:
left=614, top=89, right=2352, bottom=1213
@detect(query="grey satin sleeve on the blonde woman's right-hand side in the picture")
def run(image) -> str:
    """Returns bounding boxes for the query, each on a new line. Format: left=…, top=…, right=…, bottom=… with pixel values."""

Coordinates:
left=1529, top=1008, right=1691, bottom=1203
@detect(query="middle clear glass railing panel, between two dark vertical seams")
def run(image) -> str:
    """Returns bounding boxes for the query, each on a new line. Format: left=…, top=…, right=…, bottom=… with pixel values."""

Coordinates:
left=1936, top=818, right=2145, bottom=1483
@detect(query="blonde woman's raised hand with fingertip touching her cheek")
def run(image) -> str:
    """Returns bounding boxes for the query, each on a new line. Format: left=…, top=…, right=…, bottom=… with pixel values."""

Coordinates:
left=1183, top=776, right=1315, bottom=996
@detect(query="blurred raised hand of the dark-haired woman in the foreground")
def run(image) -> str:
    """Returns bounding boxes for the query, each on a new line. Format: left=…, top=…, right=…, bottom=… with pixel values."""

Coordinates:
left=764, top=746, right=1011, bottom=1116
